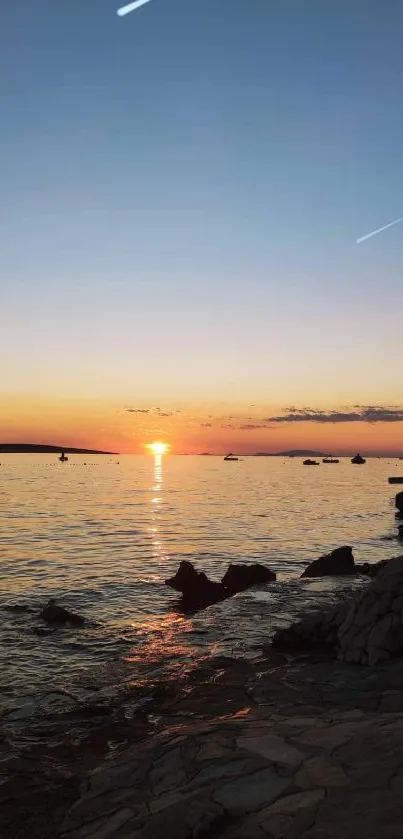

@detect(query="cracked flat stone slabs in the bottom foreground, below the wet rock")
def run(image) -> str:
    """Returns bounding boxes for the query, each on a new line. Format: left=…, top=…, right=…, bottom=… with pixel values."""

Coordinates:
left=58, top=712, right=403, bottom=839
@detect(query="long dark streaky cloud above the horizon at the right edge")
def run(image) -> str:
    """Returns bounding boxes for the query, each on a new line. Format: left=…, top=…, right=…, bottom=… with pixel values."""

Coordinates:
left=265, top=405, right=403, bottom=424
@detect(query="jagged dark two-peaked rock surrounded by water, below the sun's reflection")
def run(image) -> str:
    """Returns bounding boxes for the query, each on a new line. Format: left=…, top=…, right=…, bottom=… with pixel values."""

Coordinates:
left=165, top=560, right=276, bottom=612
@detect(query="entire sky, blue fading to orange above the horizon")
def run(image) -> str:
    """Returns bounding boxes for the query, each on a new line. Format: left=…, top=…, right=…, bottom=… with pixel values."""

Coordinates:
left=0, top=0, right=403, bottom=453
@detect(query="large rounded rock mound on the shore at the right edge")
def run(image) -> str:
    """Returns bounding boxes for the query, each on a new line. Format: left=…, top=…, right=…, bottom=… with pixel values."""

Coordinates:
left=273, top=556, right=403, bottom=665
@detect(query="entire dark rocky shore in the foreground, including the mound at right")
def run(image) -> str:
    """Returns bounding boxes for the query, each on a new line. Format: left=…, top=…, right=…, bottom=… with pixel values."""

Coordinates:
left=0, top=557, right=403, bottom=839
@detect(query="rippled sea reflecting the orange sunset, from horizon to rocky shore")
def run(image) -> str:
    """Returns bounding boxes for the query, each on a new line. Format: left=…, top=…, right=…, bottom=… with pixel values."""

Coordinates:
left=0, top=455, right=401, bottom=720
